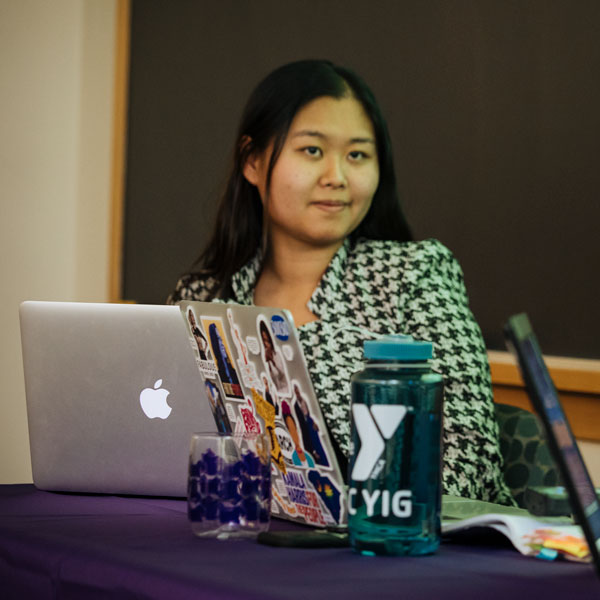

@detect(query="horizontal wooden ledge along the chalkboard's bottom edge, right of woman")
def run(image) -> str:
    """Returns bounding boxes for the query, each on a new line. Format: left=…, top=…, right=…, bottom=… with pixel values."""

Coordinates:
left=488, top=351, right=600, bottom=394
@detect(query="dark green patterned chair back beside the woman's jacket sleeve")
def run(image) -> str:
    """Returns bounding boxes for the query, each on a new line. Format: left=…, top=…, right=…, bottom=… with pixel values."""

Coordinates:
left=495, top=403, right=562, bottom=507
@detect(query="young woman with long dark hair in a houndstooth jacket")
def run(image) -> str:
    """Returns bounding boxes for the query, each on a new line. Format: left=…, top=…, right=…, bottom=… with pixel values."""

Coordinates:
left=169, top=60, right=513, bottom=504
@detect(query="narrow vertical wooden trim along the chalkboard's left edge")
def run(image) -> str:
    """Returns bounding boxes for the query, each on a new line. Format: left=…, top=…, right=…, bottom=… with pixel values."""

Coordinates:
left=108, top=0, right=131, bottom=302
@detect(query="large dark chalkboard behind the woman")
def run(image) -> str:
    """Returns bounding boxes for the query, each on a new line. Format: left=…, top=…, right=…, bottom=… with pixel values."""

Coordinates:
left=123, top=0, right=600, bottom=358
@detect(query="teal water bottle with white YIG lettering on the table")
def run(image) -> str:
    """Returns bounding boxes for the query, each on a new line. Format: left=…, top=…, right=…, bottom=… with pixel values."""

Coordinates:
left=348, top=336, right=443, bottom=555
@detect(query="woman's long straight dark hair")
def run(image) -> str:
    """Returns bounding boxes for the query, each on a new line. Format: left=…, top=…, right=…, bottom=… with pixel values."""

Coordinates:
left=194, top=60, right=412, bottom=297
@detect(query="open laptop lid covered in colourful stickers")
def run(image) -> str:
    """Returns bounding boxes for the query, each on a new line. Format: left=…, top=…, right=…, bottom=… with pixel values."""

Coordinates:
left=180, top=302, right=347, bottom=527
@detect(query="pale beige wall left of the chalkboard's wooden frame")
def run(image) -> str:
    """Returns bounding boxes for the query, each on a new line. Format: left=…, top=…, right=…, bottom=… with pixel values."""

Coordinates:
left=0, top=0, right=116, bottom=483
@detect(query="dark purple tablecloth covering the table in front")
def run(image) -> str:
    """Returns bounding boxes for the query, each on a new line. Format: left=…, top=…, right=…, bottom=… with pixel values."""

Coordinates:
left=0, top=485, right=600, bottom=600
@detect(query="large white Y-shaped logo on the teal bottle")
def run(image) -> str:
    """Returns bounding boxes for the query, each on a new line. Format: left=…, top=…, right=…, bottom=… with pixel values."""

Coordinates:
left=350, top=404, right=406, bottom=481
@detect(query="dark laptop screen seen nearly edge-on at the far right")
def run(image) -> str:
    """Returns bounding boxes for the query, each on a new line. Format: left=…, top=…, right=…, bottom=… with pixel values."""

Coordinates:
left=504, top=314, right=600, bottom=576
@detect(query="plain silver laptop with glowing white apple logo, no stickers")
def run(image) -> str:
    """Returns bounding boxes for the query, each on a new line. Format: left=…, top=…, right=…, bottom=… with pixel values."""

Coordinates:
left=20, top=302, right=217, bottom=497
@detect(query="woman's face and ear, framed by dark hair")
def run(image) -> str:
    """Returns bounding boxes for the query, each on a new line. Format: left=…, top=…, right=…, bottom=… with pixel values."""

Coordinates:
left=244, top=96, right=379, bottom=253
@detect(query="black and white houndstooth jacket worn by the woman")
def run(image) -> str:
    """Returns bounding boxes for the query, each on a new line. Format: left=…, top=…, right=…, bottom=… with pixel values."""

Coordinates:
left=168, top=239, right=514, bottom=504
